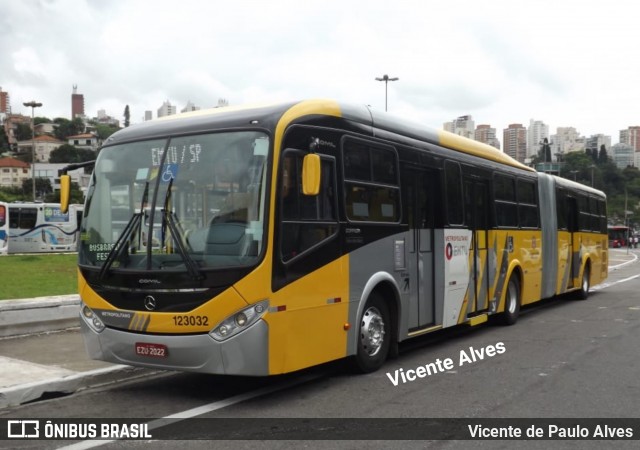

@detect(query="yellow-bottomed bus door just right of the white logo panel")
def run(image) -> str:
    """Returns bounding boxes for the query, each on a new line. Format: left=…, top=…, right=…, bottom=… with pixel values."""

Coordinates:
left=465, top=179, right=492, bottom=315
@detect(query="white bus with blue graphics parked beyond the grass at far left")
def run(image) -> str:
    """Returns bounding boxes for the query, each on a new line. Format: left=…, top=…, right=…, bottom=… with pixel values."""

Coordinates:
left=5, top=202, right=83, bottom=253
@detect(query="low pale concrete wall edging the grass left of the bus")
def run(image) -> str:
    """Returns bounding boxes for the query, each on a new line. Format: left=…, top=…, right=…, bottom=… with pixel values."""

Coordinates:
left=0, top=294, right=80, bottom=337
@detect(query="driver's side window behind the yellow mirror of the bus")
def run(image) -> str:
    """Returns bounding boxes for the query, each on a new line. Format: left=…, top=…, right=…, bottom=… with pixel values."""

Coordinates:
left=280, top=150, right=338, bottom=262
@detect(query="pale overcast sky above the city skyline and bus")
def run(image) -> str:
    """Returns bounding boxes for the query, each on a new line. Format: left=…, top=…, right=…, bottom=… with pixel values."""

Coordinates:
left=0, top=0, right=640, bottom=144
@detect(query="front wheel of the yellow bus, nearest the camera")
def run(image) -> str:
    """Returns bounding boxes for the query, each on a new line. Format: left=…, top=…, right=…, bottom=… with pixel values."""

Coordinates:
left=352, top=292, right=391, bottom=373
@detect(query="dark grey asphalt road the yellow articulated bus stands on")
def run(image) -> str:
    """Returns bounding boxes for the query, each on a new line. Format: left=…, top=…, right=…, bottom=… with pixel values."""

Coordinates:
left=0, top=250, right=640, bottom=449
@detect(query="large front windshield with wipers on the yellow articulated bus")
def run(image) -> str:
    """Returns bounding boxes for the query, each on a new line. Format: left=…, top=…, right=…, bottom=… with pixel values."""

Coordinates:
left=78, top=131, right=269, bottom=276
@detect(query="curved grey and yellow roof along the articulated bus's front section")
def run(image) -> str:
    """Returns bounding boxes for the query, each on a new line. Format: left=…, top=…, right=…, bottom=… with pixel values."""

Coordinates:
left=105, top=99, right=535, bottom=172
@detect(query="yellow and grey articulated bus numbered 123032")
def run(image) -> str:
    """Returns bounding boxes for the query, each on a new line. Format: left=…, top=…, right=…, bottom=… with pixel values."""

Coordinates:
left=63, top=100, right=608, bottom=376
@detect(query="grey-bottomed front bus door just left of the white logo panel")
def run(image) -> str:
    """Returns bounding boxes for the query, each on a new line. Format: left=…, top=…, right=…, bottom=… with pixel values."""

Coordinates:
left=401, top=167, right=440, bottom=329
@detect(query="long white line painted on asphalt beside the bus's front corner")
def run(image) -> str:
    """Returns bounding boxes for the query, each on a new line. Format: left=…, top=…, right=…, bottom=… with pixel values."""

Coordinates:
left=58, top=374, right=323, bottom=450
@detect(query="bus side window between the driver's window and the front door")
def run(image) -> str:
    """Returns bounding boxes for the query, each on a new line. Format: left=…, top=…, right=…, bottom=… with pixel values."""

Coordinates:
left=343, top=139, right=400, bottom=223
